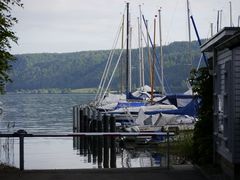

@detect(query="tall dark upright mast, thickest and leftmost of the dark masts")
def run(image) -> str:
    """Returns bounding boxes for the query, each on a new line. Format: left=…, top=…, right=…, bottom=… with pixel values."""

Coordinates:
left=126, top=3, right=129, bottom=99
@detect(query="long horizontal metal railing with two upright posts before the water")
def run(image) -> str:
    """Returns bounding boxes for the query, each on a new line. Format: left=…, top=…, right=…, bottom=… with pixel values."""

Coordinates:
left=0, top=130, right=174, bottom=171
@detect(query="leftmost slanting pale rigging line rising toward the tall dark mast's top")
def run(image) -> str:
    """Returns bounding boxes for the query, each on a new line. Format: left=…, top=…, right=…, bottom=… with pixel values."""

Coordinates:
left=95, top=7, right=126, bottom=101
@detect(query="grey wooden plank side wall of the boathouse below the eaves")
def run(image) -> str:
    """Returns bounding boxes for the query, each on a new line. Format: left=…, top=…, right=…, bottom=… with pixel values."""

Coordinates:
left=214, top=49, right=234, bottom=162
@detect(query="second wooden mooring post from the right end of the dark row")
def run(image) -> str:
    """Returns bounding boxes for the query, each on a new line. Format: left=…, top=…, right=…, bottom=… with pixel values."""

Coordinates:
left=103, top=115, right=109, bottom=168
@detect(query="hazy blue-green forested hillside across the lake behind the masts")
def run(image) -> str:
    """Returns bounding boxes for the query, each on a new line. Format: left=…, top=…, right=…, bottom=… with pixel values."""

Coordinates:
left=7, top=42, right=205, bottom=92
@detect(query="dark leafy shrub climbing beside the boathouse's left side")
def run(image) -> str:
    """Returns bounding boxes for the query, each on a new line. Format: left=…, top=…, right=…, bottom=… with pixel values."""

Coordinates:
left=190, top=67, right=213, bottom=165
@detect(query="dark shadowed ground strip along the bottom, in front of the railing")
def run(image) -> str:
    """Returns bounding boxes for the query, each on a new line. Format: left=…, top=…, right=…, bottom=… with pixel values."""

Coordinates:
left=0, top=165, right=207, bottom=180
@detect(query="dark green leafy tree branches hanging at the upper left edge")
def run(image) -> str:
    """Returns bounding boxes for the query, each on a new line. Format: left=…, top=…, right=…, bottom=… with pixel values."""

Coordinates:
left=0, top=0, right=23, bottom=94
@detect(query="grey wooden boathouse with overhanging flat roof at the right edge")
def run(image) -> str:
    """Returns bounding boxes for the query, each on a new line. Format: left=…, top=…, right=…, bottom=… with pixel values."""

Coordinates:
left=201, top=27, right=240, bottom=179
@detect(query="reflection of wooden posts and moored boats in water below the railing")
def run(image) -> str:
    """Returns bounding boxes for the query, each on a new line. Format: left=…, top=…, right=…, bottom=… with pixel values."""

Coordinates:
left=73, top=136, right=167, bottom=168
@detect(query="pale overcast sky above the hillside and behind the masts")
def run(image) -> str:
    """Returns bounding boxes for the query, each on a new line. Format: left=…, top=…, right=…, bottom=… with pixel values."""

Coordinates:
left=12, top=0, right=240, bottom=54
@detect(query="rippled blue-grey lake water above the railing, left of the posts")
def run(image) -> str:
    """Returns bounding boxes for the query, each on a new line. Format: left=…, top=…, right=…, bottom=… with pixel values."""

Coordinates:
left=0, top=94, right=94, bottom=133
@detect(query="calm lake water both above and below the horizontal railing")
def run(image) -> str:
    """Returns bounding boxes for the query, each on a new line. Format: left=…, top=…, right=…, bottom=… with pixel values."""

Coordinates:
left=0, top=94, right=165, bottom=169
